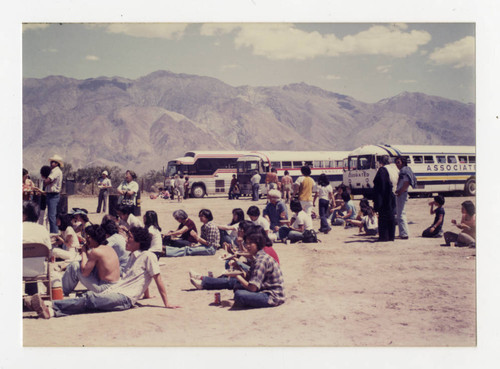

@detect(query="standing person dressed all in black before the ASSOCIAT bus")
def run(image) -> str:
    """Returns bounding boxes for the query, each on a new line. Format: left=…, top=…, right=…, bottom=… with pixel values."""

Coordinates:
left=373, top=155, right=396, bottom=242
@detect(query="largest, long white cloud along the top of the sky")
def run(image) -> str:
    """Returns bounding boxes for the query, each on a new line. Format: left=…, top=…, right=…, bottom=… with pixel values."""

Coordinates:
left=200, top=23, right=431, bottom=60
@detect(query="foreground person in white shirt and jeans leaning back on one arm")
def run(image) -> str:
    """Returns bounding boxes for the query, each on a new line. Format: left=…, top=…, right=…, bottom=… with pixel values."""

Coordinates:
left=26, top=227, right=179, bottom=319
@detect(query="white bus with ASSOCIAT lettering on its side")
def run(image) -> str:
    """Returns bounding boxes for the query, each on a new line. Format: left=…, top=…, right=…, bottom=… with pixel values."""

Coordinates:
left=344, top=145, right=476, bottom=197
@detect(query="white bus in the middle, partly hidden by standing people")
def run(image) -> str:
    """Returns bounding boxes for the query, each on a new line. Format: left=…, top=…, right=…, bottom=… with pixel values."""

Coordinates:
left=237, top=151, right=349, bottom=195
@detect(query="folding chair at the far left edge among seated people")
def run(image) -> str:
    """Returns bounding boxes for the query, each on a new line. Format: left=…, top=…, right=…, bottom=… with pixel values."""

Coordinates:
left=23, top=243, right=52, bottom=301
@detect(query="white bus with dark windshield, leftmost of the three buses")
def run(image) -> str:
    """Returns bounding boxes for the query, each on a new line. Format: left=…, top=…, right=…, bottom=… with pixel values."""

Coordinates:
left=165, top=151, right=250, bottom=198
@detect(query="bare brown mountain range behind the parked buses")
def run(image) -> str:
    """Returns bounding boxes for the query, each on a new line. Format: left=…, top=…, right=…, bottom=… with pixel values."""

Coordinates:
left=23, top=71, right=475, bottom=174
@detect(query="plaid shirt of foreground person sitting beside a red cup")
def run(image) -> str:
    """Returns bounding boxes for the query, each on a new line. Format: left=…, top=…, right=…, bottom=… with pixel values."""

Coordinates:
left=248, top=250, right=285, bottom=306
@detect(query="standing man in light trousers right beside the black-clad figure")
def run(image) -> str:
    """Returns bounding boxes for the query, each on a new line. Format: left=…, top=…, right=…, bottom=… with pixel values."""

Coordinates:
left=396, top=156, right=417, bottom=240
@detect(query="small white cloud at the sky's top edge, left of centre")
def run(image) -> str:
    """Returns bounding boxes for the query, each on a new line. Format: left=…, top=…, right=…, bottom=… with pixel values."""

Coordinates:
left=106, top=23, right=188, bottom=40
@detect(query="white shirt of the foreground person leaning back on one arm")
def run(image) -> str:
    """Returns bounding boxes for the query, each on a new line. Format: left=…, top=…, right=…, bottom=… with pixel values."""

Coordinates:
left=101, top=250, right=160, bottom=304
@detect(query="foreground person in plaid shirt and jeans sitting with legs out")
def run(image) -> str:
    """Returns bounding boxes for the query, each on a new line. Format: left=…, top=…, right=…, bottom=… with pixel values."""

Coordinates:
left=190, top=233, right=285, bottom=308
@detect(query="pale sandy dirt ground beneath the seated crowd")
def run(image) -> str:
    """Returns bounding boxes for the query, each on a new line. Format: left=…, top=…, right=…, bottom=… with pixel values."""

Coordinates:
left=22, top=194, right=477, bottom=347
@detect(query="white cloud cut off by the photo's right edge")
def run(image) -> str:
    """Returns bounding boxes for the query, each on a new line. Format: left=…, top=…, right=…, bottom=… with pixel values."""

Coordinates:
left=429, top=36, right=475, bottom=68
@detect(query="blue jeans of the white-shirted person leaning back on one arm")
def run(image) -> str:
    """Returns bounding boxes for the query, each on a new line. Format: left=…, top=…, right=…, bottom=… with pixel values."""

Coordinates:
left=52, top=292, right=132, bottom=317
